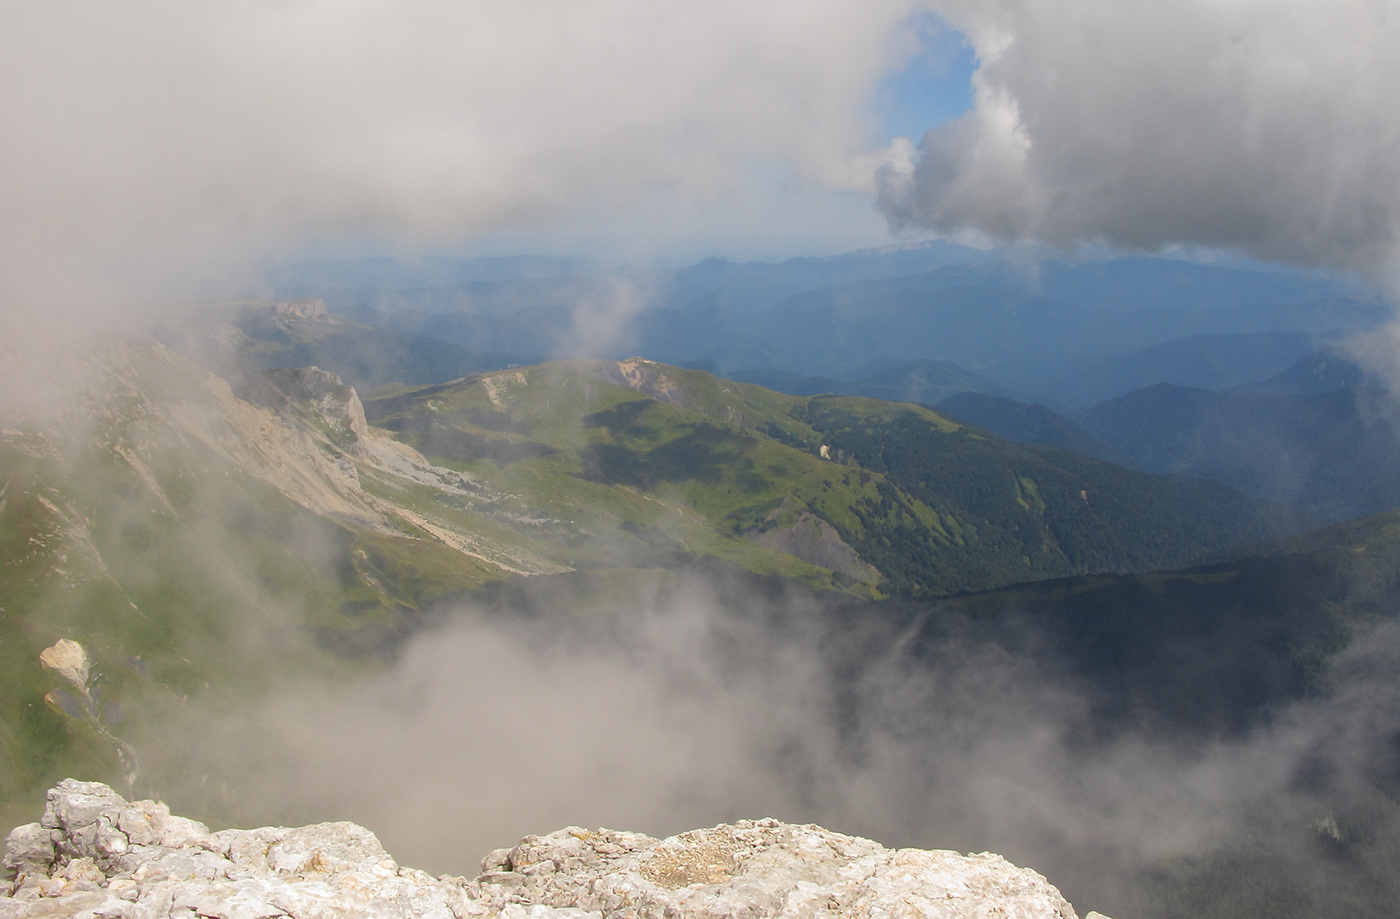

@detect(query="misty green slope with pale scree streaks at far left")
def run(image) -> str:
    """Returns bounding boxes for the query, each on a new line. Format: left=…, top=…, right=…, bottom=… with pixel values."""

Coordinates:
left=0, top=349, right=526, bottom=801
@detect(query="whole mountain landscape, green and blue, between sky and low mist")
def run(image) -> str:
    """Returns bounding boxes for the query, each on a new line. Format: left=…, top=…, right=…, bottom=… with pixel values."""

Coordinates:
left=0, top=240, right=1400, bottom=915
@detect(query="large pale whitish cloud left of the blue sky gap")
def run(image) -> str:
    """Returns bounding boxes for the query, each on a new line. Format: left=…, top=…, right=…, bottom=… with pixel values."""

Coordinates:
left=0, top=0, right=911, bottom=316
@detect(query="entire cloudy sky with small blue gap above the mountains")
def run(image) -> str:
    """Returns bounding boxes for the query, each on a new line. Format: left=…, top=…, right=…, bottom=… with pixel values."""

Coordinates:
left=0, top=0, right=1400, bottom=311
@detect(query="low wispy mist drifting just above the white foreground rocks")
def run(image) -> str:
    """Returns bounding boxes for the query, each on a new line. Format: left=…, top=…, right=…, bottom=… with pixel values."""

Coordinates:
left=144, top=577, right=1400, bottom=915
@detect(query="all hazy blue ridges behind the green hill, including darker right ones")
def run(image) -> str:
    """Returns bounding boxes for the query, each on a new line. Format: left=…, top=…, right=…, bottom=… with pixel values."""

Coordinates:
left=254, top=244, right=1396, bottom=535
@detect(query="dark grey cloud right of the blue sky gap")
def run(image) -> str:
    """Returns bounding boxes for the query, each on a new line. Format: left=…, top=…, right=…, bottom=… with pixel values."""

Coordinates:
left=879, top=0, right=1400, bottom=277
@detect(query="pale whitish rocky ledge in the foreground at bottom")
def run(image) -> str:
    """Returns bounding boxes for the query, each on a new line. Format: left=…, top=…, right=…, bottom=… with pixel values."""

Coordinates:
left=0, top=779, right=1102, bottom=919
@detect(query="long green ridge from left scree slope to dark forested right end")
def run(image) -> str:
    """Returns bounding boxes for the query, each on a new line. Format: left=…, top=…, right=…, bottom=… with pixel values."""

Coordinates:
left=0, top=347, right=1282, bottom=800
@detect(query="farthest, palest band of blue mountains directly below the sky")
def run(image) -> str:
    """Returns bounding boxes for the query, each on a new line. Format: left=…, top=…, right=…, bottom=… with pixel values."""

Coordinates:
left=264, top=242, right=1389, bottom=392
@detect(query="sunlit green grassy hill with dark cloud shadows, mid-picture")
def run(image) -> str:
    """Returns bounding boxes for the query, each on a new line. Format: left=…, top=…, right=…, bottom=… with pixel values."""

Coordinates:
left=365, top=361, right=878, bottom=591
